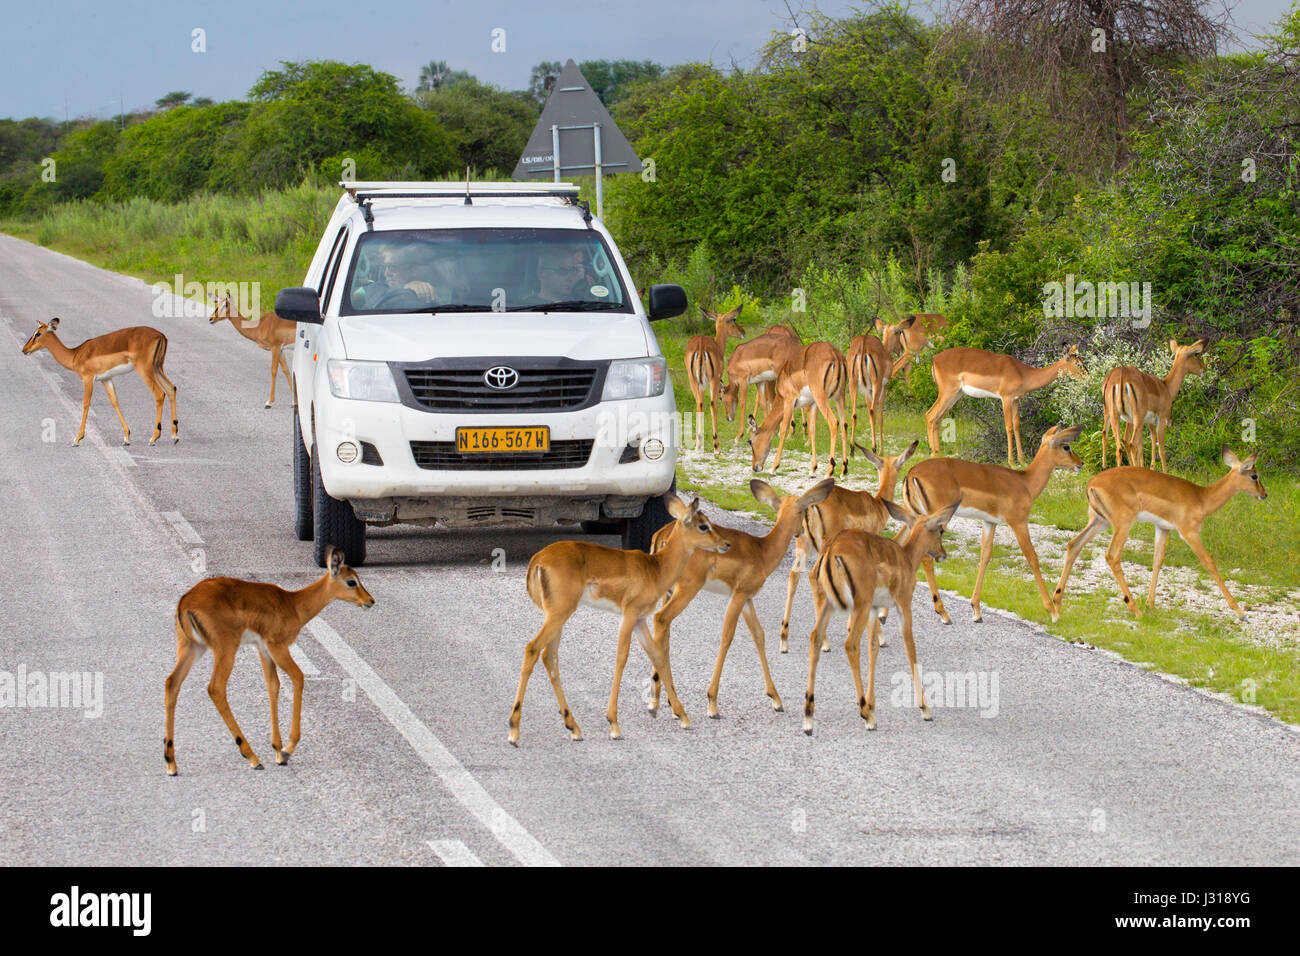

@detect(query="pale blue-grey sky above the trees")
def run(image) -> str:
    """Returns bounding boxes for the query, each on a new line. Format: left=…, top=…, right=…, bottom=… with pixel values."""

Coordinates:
left=0, top=0, right=1292, bottom=120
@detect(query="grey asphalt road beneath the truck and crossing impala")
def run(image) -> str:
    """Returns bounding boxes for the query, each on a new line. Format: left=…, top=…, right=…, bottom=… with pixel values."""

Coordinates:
left=0, top=237, right=1300, bottom=865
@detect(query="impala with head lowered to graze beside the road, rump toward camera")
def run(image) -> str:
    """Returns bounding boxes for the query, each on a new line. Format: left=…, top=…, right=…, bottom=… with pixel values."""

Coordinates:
left=749, top=342, right=849, bottom=476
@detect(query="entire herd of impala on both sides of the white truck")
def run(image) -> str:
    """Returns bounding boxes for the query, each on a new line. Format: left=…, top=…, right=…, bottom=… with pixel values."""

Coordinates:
left=22, top=297, right=1266, bottom=775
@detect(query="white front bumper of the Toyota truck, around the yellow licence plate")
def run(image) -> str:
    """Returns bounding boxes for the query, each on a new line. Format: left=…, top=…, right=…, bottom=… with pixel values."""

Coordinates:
left=312, top=389, right=677, bottom=527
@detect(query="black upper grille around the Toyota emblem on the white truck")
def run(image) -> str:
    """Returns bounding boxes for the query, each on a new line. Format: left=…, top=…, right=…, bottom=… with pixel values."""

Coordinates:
left=403, top=365, right=599, bottom=411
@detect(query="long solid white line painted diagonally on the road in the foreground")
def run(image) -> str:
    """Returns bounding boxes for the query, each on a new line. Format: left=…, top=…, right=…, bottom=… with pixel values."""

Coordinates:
left=307, top=618, right=560, bottom=866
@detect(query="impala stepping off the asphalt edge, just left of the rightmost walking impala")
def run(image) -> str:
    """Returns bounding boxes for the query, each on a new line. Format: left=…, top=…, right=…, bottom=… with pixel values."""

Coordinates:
left=902, top=425, right=1083, bottom=624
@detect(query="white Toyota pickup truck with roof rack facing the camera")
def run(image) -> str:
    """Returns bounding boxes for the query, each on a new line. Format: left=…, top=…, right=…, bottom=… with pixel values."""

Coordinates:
left=276, top=182, right=686, bottom=566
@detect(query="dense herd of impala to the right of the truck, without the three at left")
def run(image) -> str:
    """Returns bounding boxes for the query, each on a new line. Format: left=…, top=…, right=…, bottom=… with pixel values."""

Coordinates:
left=508, top=308, right=1266, bottom=745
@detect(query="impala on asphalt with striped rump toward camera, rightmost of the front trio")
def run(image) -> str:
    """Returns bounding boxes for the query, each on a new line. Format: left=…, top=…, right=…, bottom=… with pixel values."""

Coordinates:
left=803, top=501, right=959, bottom=735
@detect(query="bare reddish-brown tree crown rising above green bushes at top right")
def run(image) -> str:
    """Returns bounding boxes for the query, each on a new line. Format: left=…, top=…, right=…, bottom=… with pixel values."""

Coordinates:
left=948, top=0, right=1229, bottom=165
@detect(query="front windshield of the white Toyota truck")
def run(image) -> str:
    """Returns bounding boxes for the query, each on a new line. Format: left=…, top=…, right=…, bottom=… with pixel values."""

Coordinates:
left=339, top=229, right=632, bottom=315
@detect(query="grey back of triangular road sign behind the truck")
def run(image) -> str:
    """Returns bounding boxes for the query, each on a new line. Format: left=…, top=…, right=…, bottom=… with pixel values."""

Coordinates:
left=511, top=60, right=641, bottom=179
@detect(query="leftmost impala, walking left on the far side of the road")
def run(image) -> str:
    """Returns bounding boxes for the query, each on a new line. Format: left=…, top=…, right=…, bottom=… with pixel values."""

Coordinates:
left=22, top=319, right=181, bottom=445
